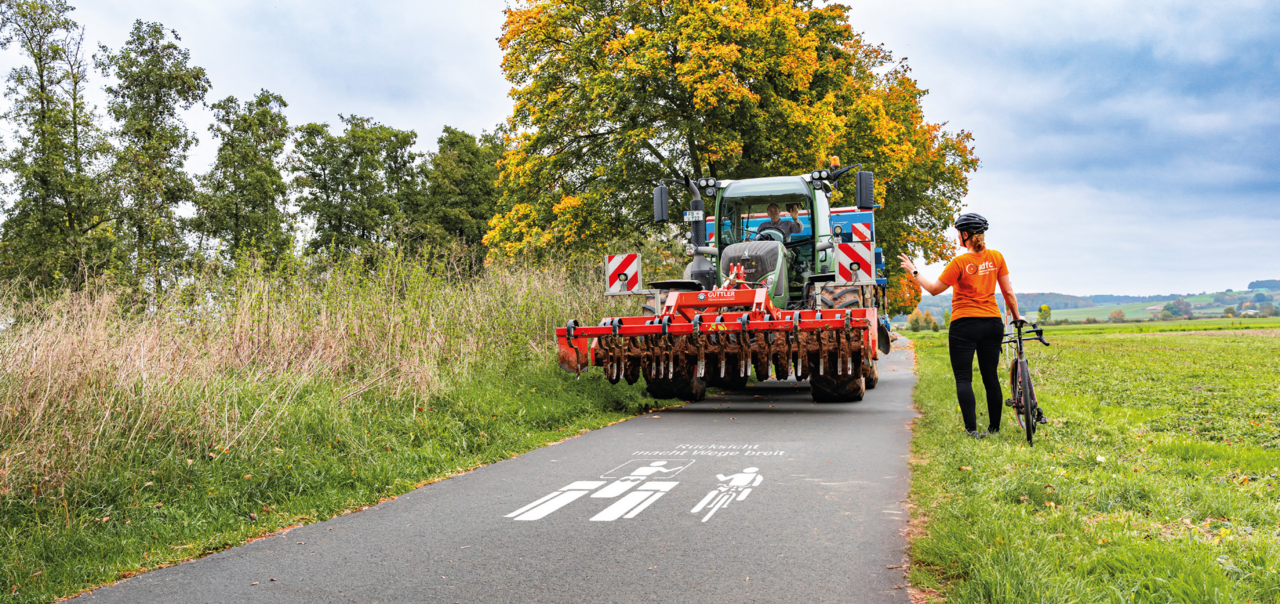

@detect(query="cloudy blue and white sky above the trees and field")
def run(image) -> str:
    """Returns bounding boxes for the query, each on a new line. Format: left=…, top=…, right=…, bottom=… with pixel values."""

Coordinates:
left=0, top=0, right=1280, bottom=294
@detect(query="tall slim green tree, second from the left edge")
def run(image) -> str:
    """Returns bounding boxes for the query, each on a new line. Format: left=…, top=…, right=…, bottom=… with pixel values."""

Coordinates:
left=95, top=19, right=209, bottom=292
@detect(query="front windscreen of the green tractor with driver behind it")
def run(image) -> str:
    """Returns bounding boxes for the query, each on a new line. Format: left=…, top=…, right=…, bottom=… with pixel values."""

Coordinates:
left=718, top=177, right=813, bottom=244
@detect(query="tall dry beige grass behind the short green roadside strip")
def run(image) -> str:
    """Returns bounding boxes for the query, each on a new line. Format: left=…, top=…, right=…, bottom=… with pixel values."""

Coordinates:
left=0, top=249, right=636, bottom=494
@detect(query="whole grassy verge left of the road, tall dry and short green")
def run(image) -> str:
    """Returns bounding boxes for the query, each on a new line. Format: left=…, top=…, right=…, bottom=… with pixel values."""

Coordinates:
left=0, top=252, right=653, bottom=603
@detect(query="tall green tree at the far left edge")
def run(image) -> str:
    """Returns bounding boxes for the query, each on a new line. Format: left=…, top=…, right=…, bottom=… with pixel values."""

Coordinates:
left=0, top=0, right=113, bottom=287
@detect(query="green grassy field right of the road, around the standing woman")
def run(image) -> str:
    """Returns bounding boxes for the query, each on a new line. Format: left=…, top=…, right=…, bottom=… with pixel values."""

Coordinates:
left=909, top=321, right=1280, bottom=603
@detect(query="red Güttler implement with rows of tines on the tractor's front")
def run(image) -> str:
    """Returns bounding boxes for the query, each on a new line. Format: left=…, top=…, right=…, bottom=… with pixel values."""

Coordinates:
left=556, top=277, right=878, bottom=402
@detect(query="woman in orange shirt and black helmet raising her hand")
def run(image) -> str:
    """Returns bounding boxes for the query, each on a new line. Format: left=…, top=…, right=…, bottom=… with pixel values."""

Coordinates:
left=899, top=214, right=1021, bottom=439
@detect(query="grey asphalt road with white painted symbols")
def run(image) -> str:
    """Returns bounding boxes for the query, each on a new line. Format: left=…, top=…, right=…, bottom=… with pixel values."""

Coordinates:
left=79, top=342, right=915, bottom=604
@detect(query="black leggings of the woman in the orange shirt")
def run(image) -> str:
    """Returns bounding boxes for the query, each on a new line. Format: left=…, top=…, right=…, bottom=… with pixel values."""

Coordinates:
left=947, top=316, right=1005, bottom=431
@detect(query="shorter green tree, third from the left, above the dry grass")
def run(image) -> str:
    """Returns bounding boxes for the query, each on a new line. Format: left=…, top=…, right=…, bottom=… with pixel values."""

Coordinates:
left=192, top=91, right=293, bottom=258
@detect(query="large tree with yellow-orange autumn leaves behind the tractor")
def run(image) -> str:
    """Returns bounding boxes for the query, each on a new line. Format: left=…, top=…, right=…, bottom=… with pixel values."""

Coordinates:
left=485, top=0, right=978, bottom=312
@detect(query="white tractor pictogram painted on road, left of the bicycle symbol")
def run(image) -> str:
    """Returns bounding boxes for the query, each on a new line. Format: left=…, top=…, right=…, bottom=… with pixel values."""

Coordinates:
left=507, top=459, right=694, bottom=522
